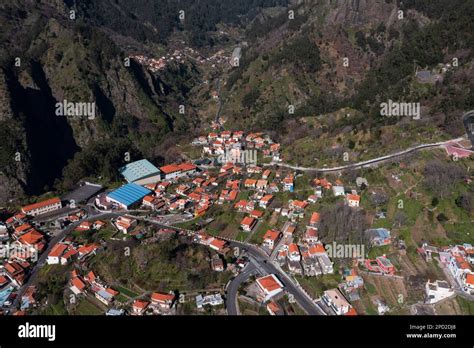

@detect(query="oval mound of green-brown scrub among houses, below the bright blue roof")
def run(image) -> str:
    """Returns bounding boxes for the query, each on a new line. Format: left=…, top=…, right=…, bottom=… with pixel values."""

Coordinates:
left=91, top=238, right=233, bottom=290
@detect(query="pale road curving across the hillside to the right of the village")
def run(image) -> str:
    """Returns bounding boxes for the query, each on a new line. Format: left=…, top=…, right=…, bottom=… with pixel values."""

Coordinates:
left=264, top=137, right=465, bottom=173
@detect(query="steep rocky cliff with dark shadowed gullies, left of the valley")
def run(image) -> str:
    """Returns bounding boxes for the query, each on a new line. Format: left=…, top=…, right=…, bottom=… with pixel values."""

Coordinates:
left=0, top=1, right=197, bottom=204
